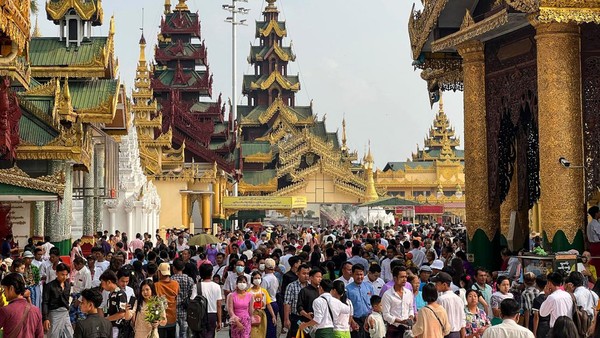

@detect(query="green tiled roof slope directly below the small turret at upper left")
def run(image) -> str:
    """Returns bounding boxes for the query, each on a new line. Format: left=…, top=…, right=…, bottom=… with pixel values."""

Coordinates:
left=29, top=37, right=108, bottom=67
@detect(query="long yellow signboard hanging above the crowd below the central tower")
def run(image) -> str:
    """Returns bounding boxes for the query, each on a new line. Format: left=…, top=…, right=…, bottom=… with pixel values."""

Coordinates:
left=223, top=196, right=307, bottom=210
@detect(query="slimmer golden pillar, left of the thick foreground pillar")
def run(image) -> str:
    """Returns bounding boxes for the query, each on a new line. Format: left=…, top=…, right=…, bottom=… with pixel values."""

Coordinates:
left=458, top=41, right=500, bottom=268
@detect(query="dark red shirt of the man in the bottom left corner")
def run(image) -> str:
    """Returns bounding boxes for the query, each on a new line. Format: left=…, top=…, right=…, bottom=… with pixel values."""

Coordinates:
left=0, top=298, right=44, bottom=338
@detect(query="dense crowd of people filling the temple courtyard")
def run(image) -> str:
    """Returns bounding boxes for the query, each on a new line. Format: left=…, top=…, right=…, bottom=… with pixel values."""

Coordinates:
left=0, top=224, right=598, bottom=338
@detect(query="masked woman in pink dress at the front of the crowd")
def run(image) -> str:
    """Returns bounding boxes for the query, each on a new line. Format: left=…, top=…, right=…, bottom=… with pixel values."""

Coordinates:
left=227, top=275, right=254, bottom=338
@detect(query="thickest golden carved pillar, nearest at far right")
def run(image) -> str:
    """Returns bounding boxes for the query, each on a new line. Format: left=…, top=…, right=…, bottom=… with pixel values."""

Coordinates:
left=534, top=23, right=585, bottom=251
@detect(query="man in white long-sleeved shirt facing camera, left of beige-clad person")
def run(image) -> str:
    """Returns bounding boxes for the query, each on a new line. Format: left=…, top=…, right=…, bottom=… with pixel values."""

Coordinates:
left=381, top=266, right=415, bottom=337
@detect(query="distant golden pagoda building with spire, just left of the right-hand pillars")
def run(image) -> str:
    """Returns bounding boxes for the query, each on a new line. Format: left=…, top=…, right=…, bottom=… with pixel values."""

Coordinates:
left=375, top=99, right=465, bottom=222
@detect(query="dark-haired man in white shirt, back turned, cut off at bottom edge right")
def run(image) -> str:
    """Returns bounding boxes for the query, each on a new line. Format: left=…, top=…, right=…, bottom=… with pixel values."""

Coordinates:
left=481, top=298, right=535, bottom=338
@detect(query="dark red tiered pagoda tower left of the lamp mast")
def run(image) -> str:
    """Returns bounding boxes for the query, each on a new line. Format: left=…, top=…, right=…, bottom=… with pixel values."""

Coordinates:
left=148, top=0, right=235, bottom=173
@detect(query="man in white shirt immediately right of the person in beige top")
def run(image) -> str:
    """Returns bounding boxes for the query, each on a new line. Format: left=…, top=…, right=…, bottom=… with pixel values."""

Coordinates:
left=431, top=272, right=466, bottom=338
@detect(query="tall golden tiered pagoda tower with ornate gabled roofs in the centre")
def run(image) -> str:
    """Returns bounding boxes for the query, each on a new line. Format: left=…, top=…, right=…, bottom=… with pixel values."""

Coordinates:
left=237, top=0, right=373, bottom=203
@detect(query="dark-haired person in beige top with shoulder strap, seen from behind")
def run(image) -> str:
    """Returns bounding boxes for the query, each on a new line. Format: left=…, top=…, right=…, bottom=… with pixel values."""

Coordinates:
left=412, top=283, right=450, bottom=338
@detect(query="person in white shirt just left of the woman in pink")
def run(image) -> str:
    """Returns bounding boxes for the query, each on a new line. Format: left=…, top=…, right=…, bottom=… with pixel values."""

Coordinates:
left=197, top=264, right=223, bottom=338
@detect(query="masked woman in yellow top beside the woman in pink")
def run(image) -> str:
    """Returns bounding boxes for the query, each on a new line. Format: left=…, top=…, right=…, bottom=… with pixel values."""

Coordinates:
left=249, top=271, right=277, bottom=338
